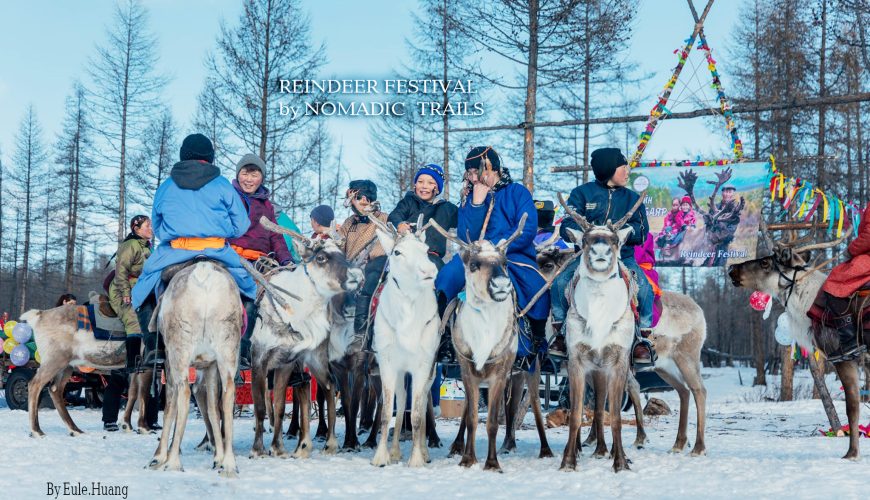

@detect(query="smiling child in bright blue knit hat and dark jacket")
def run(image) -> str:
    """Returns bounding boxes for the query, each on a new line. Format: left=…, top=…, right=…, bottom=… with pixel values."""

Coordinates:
left=387, top=163, right=458, bottom=269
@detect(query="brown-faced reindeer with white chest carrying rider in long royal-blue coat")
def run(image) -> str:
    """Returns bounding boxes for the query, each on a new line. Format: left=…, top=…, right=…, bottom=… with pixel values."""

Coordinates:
left=432, top=214, right=526, bottom=471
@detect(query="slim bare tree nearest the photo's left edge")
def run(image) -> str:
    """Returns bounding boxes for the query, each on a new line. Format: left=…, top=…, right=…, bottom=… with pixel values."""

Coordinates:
left=12, top=104, right=48, bottom=314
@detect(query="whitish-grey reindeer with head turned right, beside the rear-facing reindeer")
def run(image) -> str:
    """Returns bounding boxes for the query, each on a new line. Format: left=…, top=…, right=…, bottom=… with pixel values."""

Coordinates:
left=251, top=217, right=362, bottom=458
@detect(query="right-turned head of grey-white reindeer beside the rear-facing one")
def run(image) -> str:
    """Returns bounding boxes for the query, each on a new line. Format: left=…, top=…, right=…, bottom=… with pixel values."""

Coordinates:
left=260, top=217, right=362, bottom=298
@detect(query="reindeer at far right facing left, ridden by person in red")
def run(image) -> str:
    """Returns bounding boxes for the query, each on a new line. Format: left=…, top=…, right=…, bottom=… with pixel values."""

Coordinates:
left=728, top=229, right=866, bottom=460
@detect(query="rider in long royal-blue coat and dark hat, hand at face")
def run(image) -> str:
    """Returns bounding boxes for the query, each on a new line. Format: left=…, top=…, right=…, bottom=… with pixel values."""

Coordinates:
left=435, top=146, right=550, bottom=363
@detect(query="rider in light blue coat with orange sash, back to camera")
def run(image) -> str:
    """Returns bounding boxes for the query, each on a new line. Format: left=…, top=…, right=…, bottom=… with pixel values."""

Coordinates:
left=132, top=134, right=257, bottom=360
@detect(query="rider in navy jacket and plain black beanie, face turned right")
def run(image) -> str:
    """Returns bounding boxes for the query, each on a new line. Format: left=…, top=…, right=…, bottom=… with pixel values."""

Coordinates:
left=550, top=148, right=655, bottom=371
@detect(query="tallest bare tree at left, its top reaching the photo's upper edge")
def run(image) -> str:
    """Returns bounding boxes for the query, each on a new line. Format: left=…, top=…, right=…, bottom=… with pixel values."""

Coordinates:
left=89, top=0, right=166, bottom=241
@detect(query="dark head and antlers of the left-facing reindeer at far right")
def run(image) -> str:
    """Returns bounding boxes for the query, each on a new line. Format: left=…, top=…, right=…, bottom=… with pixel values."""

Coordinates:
left=728, top=220, right=846, bottom=296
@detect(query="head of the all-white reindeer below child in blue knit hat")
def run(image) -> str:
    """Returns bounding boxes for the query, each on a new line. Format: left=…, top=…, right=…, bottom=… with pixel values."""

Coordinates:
left=369, top=214, right=438, bottom=291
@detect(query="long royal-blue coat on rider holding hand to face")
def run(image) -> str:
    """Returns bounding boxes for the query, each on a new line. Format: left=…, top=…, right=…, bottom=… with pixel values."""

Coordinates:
left=435, top=183, right=550, bottom=319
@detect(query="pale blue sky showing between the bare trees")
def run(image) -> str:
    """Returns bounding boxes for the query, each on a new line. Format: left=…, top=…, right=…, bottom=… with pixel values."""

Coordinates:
left=0, top=0, right=742, bottom=186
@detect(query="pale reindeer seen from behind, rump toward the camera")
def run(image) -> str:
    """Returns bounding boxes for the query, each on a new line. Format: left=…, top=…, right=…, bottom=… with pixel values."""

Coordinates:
left=149, top=260, right=243, bottom=477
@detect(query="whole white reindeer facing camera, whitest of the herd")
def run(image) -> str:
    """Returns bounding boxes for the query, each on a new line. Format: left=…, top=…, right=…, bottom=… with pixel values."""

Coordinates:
left=371, top=215, right=441, bottom=467
